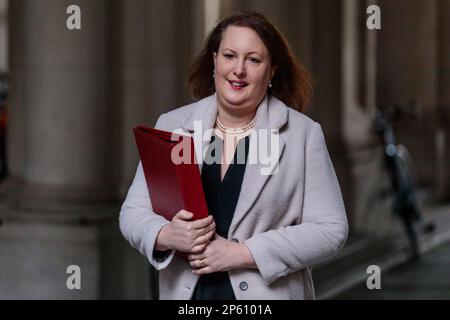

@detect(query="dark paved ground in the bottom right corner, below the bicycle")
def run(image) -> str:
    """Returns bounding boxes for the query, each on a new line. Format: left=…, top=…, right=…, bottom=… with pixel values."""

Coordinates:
left=335, top=242, right=450, bottom=300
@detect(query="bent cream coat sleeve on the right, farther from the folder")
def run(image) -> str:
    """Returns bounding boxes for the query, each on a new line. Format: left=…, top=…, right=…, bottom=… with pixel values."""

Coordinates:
left=245, top=123, right=348, bottom=284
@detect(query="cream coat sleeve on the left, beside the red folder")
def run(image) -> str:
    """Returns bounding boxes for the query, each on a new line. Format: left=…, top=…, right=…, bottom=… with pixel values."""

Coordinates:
left=119, top=115, right=175, bottom=270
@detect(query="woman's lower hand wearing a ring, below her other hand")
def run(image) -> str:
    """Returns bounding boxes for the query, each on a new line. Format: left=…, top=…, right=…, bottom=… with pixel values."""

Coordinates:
left=188, top=234, right=257, bottom=275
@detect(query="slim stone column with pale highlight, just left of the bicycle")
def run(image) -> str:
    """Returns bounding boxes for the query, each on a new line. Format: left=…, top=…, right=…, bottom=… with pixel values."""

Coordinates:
left=340, top=0, right=393, bottom=233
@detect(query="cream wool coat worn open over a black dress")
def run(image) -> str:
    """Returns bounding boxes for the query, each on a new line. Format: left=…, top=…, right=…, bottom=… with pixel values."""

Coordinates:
left=120, top=95, right=348, bottom=299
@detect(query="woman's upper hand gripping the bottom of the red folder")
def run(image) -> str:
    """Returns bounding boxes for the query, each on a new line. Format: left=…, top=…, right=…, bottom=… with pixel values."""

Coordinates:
left=155, top=210, right=216, bottom=254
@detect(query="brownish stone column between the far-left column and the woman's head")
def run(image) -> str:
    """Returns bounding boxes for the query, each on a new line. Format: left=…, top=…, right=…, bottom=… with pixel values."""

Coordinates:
left=113, top=0, right=205, bottom=197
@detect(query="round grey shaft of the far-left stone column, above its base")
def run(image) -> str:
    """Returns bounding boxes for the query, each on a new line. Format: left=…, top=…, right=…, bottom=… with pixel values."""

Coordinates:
left=8, top=0, right=114, bottom=208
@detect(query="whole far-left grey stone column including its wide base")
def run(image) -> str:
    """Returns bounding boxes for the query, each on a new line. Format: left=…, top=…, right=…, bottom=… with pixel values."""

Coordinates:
left=0, top=0, right=117, bottom=299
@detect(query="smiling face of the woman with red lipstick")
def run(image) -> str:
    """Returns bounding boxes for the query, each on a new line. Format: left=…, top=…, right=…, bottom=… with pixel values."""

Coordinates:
left=214, top=26, right=273, bottom=111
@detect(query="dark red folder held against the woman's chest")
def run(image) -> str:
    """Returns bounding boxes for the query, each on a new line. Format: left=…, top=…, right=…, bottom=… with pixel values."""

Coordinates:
left=133, top=126, right=208, bottom=221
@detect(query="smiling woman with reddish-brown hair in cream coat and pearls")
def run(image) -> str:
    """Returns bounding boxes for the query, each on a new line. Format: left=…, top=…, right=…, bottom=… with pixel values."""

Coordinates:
left=120, top=12, right=348, bottom=299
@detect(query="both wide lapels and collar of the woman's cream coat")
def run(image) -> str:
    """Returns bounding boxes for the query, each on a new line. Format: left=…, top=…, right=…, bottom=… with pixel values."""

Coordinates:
left=182, top=94, right=288, bottom=235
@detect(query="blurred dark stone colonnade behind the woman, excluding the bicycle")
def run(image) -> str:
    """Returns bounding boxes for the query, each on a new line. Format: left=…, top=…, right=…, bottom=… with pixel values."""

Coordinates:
left=0, top=0, right=450, bottom=299
